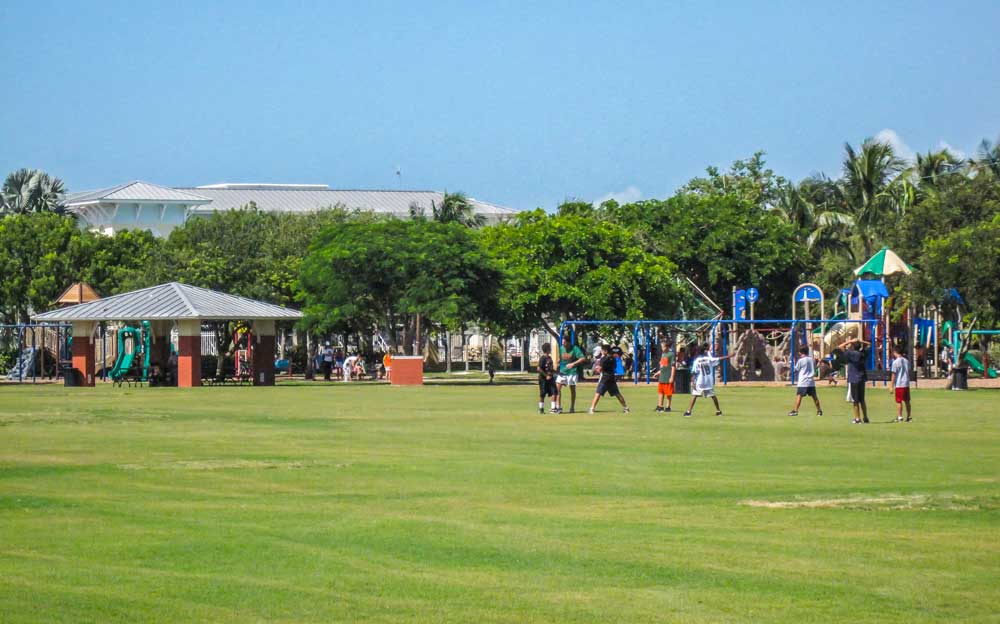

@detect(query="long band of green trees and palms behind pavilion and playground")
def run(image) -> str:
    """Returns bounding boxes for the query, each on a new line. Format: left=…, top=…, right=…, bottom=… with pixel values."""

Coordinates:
left=0, top=134, right=1000, bottom=347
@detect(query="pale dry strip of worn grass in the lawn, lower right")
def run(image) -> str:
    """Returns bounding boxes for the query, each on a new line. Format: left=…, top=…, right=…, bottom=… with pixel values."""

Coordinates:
left=739, top=494, right=998, bottom=511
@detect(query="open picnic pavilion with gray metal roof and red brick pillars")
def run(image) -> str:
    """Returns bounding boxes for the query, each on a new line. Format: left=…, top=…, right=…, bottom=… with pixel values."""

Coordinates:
left=32, top=282, right=302, bottom=387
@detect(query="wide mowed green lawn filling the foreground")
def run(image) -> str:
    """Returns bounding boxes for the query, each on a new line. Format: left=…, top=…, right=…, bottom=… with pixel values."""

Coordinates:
left=0, top=384, right=1000, bottom=623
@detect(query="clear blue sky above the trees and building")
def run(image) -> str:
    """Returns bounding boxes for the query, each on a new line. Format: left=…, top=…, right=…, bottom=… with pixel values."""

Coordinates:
left=0, top=0, right=1000, bottom=209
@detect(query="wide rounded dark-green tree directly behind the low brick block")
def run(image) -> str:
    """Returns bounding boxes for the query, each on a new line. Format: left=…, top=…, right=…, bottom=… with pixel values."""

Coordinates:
left=299, top=219, right=501, bottom=352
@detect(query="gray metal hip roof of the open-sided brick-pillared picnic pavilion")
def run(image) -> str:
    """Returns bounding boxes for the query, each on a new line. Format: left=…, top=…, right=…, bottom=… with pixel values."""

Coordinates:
left=32, top=282, right=302, bottom=322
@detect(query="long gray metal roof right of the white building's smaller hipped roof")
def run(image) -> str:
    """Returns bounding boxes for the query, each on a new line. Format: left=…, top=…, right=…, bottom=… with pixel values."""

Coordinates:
left=179, top=187, right=517, bottom=219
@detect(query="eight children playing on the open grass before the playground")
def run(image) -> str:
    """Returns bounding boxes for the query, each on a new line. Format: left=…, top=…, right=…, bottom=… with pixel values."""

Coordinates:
left=538, top=336, right=913, bottom=424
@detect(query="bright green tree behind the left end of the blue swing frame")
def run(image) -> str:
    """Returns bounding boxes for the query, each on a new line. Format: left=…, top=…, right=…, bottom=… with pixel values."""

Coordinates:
left=483, top=210, right=684, bottom=336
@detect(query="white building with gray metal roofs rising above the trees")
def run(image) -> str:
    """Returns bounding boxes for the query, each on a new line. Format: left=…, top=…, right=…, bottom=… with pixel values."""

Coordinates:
left=63, top=181, right=517, bottom=236
